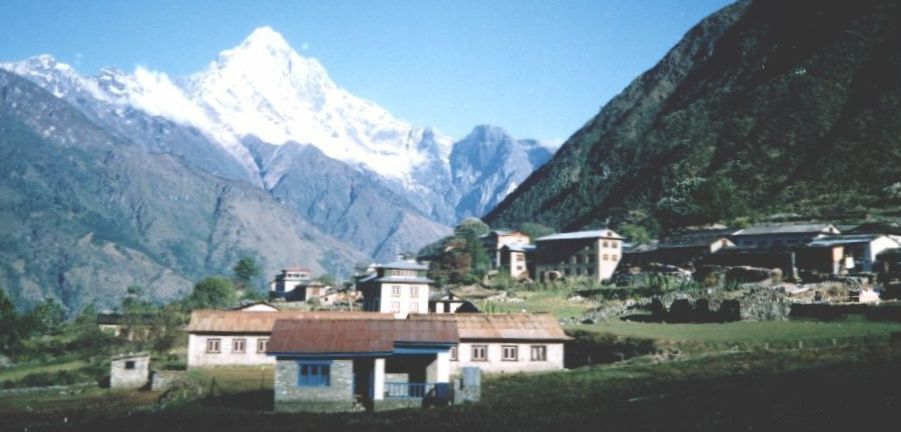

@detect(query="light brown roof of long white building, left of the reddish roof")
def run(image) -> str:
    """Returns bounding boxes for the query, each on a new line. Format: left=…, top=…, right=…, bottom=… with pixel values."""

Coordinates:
left=188, top=309, right=394, bottom=333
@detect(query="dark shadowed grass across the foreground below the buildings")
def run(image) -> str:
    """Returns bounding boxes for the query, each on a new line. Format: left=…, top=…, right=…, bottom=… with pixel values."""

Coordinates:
left=0, top=342, right=901, bottom=432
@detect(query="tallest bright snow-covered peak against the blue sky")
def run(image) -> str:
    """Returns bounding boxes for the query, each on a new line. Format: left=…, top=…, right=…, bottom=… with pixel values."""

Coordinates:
left=186, top=27, right=451, bottom=185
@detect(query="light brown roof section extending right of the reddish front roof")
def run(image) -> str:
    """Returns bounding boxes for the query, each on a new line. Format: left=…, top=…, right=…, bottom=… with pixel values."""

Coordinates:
left=407, top=313, right=572, bottom=341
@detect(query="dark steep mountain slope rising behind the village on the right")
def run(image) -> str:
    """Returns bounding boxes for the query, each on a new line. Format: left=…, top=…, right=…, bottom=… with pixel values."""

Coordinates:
left=486, top=0, right=901, bottom=233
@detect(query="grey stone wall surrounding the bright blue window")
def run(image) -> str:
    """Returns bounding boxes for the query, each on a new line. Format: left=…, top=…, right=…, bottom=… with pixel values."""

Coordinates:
left=274, top=359, right=354, bottom=412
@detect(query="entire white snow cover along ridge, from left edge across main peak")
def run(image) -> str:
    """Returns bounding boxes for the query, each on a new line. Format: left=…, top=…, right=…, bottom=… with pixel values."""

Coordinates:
left=0, top=27, right=453, bottom=190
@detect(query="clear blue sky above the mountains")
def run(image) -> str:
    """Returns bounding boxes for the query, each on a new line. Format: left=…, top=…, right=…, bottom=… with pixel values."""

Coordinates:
left=0, top=0, right=730, bottom=145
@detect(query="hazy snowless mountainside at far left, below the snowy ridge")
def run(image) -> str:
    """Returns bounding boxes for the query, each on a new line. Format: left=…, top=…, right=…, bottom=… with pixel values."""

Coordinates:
left=0, top=71, right=367, bottom=311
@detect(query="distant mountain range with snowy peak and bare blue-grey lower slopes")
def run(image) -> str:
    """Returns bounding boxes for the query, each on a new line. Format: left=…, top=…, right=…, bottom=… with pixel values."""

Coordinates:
left=0, top=27, right=551, bottom=309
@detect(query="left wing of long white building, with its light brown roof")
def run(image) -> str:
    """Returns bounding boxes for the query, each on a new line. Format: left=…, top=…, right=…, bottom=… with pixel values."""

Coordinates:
left=187, top=309, right=393, bottom=369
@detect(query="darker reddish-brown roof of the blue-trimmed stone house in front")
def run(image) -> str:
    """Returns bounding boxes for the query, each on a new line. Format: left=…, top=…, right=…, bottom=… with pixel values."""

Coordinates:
left=267, top=319, right=459, bottom=354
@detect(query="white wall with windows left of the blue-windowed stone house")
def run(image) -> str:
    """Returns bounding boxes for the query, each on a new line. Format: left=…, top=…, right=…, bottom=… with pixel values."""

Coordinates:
left=188, top=334, right=275, bottom=369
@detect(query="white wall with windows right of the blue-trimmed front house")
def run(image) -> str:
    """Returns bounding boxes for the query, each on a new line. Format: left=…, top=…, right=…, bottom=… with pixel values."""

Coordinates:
left=450, top=342, right=563, bottom=375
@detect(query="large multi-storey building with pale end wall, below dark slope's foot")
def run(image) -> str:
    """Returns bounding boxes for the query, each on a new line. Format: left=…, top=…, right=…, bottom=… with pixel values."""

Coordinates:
left=535, top=229, right=625, bottom=282
